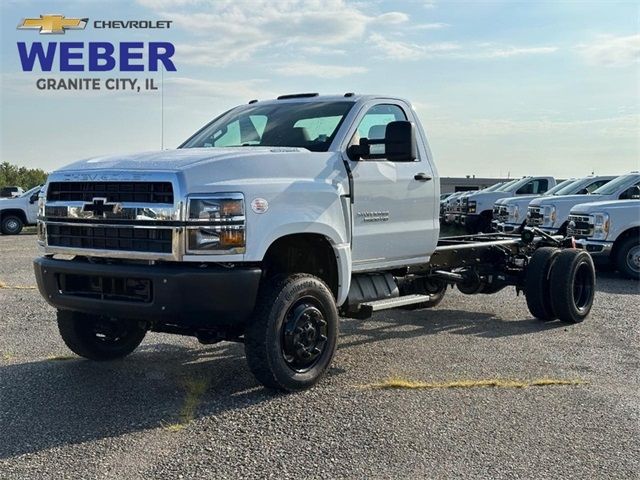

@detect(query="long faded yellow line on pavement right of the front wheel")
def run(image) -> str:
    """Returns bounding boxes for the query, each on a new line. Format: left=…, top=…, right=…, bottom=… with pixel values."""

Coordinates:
left=360, top=378, right=587, bottom=390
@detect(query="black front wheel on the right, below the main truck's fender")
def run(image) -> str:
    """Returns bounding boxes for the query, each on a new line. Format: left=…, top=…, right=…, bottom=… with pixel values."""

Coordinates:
left=245, top=274, right=338, bottom=392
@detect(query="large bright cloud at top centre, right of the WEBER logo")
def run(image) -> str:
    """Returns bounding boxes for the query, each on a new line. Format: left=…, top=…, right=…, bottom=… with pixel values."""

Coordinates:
left=137, top=0, right=416, bottom=65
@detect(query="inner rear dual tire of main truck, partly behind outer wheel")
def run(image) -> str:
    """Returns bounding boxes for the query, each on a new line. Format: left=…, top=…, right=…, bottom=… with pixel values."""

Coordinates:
left=524, top=247, right=560, bottom=322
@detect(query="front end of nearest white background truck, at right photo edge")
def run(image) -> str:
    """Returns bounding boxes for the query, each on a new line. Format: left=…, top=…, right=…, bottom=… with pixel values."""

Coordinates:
left=567, top=199, right=640, bottom=280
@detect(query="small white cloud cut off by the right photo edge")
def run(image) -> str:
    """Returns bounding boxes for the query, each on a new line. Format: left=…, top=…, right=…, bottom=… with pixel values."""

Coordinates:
left=576, top=33, right=640, bottom=67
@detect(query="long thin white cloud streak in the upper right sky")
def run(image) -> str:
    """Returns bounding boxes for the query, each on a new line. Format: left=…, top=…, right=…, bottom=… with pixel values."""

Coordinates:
left=369, top=33, right=558, bottom=60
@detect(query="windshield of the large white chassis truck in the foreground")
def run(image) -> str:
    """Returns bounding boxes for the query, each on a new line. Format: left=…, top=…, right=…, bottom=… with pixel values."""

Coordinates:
left=180, top=102, right=354, bottom=152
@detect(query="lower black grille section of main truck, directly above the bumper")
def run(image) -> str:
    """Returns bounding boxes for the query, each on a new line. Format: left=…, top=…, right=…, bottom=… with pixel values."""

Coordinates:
left=47, top=224, right=172, bottom=253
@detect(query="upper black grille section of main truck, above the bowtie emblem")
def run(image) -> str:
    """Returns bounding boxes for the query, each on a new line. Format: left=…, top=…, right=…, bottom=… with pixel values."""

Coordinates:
left=47, top=182, right=173, bottom=204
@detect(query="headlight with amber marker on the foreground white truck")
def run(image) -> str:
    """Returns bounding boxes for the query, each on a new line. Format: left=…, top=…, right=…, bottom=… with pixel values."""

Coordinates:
left=187, top=193, right=246, bottom=254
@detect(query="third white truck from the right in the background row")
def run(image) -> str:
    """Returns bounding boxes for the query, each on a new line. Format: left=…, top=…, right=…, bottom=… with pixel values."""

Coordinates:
left=491, top=176, right=615, bottom=233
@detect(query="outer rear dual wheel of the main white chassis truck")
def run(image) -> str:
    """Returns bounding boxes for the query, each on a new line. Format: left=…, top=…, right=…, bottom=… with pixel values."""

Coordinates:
left=550, top=249, right=596, bottom=323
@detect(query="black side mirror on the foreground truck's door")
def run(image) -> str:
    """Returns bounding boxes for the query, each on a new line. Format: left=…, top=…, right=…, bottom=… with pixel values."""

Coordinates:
left=347, top=120, right=418, bottom=162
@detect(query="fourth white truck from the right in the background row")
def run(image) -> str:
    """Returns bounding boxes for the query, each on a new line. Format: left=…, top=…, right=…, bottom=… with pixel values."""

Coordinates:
left=462, top=177, right=556, bottom=233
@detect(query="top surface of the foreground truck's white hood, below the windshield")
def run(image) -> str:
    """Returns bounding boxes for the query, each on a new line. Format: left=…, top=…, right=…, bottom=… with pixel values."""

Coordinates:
left=58, top=147, right=309, bottom=172
